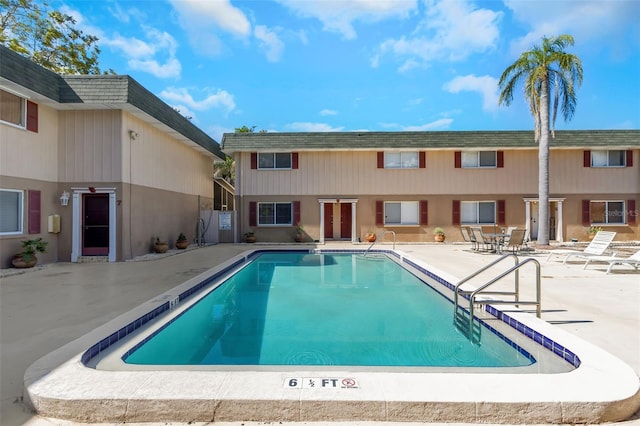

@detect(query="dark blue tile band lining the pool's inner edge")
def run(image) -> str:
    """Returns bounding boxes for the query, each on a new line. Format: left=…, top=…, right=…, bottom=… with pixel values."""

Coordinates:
left=80, top=249, right=581, bottom=368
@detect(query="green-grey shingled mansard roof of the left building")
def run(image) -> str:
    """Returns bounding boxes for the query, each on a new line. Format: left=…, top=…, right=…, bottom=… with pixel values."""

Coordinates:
left=0, top=46, right=225, bottom=160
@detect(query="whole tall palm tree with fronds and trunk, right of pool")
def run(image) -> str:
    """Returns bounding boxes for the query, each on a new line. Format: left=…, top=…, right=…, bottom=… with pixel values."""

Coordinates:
left=498, top=34, right=582, bottom=245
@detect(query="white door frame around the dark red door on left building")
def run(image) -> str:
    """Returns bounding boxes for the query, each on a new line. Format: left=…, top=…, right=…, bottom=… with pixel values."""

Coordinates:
left=71, top=187, right=116, bottom=262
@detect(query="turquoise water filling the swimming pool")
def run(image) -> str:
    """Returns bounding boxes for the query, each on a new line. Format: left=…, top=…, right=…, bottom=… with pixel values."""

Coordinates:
left=124, top=252, right=535, bottom=367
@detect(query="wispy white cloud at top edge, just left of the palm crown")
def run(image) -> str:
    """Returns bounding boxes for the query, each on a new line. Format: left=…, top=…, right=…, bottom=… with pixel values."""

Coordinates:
left=372, top=0, right=502, bottom=72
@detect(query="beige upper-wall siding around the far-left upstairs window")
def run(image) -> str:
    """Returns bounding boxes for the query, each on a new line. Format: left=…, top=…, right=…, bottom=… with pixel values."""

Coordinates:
left=0, top=105, right=58, bottom=181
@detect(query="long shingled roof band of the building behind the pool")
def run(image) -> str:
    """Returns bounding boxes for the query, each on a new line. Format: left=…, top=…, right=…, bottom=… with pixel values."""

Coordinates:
left=221, top=130, right=640, bottom=154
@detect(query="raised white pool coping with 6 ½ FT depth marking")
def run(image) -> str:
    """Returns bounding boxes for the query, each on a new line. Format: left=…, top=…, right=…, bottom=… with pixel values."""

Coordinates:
left=24, top=249, right=640, bottom=423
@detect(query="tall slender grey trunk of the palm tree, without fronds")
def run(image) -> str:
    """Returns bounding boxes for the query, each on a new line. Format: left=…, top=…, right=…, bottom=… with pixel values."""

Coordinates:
left=537, top=78, right=549, bottom=246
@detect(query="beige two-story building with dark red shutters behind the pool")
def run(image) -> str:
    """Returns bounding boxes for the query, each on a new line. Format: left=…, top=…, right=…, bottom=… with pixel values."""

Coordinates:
left=221, top=130, right=640, bottom=242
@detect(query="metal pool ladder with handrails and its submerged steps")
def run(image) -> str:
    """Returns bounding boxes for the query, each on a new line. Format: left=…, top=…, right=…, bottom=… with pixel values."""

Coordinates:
left=453, top=253, right=541, bottom=343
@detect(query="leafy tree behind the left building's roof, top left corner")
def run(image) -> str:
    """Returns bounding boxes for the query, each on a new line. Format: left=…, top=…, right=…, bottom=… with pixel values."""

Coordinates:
left=0, top=0, right=113, bottom=74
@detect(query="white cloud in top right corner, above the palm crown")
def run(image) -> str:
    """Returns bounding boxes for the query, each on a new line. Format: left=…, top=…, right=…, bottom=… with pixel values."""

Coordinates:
left=505, top=0, right=640, bottom=56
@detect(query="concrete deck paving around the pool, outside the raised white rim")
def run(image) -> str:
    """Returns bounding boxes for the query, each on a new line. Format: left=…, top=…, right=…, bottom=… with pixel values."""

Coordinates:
left=0, top=244, right=640, bottom=426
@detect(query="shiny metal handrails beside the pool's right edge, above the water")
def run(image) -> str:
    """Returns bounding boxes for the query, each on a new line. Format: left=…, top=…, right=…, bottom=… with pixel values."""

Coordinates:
left=454, top=254, right=542, bottom=336
